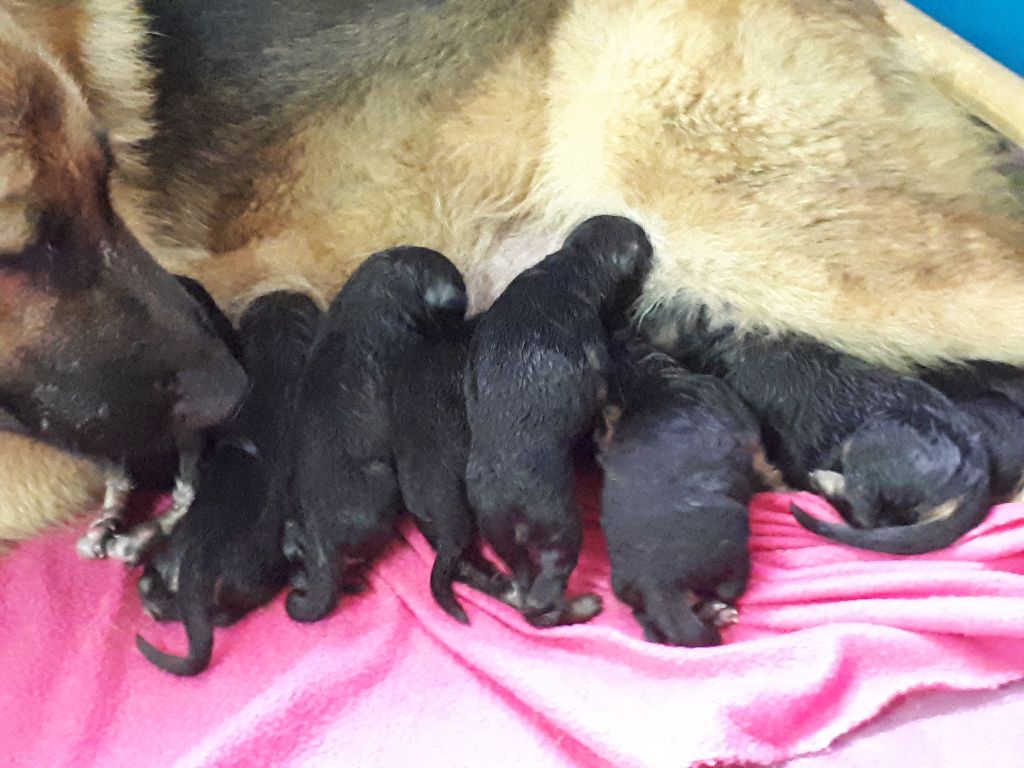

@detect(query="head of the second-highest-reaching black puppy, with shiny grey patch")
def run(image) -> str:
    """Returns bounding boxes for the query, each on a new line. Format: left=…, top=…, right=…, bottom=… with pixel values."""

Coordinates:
left=371, top=246, right=469, bottom=326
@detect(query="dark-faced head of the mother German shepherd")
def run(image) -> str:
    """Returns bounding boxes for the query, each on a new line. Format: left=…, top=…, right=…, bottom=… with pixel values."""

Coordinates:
left=0, top=24, right=246, bottom=458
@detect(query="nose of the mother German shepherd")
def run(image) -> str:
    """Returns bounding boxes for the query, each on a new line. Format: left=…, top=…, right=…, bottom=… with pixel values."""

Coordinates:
left=174, top=356, right=249, bottom=432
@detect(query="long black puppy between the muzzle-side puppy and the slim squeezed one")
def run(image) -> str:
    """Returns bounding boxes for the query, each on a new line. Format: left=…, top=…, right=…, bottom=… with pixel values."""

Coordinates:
left=285, top=247, right=466, bottom=622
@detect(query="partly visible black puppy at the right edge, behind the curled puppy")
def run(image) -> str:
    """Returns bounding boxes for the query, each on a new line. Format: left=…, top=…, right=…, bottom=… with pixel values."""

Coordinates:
left=922, top=362, right=1024, bottom=501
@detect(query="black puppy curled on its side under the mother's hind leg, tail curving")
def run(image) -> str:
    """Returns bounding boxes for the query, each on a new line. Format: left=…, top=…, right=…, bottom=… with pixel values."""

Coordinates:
left=706, top=335, right=989, bottom=555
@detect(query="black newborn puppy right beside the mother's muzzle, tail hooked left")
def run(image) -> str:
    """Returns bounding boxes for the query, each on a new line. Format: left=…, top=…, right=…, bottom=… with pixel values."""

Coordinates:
left=136, top=292, right=321, bottom=675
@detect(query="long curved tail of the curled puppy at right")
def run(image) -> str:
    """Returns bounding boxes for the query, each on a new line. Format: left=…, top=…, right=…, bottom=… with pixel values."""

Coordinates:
left=790, top=478, right=988, bottom=555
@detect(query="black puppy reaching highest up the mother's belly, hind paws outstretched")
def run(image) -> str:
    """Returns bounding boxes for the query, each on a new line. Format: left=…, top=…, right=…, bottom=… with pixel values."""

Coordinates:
left=465, top=216, right=651, bottom=626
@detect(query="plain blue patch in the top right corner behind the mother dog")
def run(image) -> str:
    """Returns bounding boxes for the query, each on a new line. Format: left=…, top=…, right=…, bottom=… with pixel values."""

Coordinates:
left=910, top=0, right=1024, bottom=75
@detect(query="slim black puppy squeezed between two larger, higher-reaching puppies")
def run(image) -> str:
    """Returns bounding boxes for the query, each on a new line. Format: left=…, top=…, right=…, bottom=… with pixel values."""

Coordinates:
left=391, top=309, right=518, bottom=624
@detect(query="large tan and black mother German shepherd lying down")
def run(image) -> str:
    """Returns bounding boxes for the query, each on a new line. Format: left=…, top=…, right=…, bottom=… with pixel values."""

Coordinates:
left=0, top=0, right=1024, bottom=537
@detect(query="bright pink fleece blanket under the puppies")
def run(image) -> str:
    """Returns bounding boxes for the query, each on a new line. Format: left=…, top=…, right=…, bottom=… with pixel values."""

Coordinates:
left=0, top=478, right=1024, bottom=768
